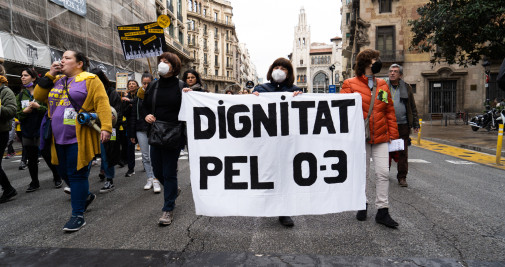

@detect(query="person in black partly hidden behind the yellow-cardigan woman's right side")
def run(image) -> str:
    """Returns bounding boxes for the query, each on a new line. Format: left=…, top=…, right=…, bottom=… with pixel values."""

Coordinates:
left=90, top=68, right=121, bottom=193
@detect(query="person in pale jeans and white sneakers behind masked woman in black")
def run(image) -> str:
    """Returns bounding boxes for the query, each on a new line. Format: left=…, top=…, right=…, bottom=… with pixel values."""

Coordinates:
left=127, top=72, right=161, bottom=193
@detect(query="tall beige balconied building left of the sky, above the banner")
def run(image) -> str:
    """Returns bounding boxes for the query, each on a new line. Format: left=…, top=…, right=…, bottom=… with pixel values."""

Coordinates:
left=187, top=0, right=240, bottom=93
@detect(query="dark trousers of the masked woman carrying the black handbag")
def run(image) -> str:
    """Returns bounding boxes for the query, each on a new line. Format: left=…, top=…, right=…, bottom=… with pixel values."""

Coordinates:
left=151, top=146, right=181, bottom=211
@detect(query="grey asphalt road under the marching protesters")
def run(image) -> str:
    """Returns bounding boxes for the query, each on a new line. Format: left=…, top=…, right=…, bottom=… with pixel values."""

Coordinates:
left=0, top=147, right=505, bottom=266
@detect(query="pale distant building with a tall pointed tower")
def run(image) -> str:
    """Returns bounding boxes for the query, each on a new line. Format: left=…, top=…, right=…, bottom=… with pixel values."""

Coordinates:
left=290, top=8, right=342, bottom=93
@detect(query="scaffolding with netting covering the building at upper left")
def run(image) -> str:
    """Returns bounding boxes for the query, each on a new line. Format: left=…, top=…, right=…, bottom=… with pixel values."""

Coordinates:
left=0, top=0, right=156, bottom=81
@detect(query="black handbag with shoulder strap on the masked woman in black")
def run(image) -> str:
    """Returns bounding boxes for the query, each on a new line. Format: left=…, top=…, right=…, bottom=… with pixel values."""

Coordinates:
left=148, top=80, right=184, bottom=149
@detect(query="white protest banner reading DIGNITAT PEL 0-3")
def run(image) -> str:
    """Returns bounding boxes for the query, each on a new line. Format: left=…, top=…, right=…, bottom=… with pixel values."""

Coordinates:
left=179, top=92, right=366, bottom=216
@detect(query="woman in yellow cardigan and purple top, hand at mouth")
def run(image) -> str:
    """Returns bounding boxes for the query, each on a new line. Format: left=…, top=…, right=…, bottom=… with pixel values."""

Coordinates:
left=34, top=50, right=112, bottom=232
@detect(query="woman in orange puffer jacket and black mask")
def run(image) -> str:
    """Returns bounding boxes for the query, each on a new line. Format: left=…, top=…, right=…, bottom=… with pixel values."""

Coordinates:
left=340, top=49, right=399, bottom=228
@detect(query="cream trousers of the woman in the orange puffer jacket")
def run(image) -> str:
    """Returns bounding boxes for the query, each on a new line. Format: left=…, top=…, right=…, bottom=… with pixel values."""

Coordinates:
left=365, top=143, right=389, bottom=209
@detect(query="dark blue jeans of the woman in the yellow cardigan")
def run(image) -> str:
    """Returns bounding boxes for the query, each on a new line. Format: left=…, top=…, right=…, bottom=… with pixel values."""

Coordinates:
left=56, top=143, right=91, bottom=216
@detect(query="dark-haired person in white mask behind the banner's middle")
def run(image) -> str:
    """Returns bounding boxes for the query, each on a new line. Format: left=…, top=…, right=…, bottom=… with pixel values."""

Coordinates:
left=253, top=57, right=302, bottom=227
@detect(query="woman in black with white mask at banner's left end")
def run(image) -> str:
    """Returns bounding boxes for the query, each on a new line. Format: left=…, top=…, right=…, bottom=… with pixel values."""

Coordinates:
left=142, top=52, right=184, bottom=225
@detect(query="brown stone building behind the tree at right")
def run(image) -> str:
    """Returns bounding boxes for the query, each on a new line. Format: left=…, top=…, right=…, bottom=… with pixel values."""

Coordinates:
left=341, top=0, right=503, bottom=117
